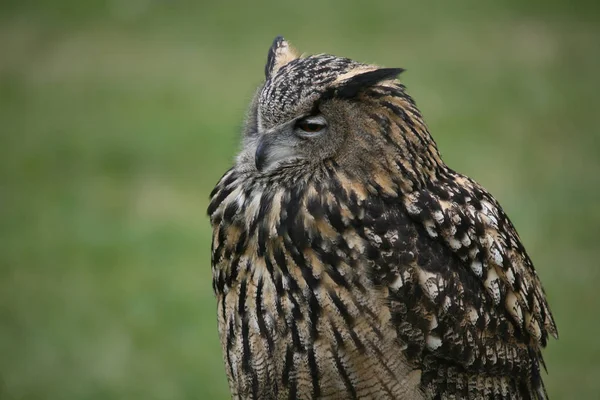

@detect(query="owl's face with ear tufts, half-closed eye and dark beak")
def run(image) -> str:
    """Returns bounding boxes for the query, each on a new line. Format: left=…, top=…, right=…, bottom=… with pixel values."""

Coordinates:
left=238, top=38, right=401, bottom=175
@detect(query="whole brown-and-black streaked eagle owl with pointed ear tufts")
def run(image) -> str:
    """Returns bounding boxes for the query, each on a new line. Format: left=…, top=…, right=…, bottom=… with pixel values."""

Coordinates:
left=208, top=37, right=557, bottom=399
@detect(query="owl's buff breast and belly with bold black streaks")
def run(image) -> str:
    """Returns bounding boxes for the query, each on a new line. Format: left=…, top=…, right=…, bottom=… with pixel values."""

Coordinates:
left=211, top=167, right=421, bottom=399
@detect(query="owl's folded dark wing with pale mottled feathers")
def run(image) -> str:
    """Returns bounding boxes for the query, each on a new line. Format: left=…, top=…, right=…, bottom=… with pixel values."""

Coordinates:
left=364, top=174, right=555, bottom=398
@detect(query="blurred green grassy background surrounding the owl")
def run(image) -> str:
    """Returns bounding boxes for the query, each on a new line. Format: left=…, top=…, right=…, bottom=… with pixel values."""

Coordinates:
left=0, top=0, right=600, bottom=400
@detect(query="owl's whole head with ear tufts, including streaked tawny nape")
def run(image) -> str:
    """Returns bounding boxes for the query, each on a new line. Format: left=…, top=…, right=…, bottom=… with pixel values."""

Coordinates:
left=237, top=37, right=441, bottom=188
